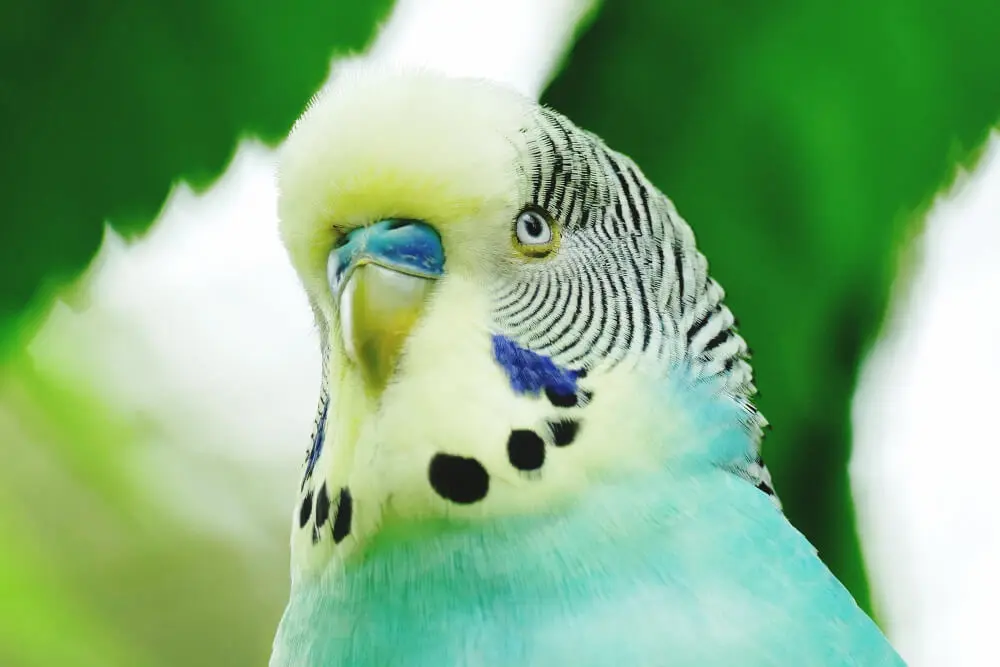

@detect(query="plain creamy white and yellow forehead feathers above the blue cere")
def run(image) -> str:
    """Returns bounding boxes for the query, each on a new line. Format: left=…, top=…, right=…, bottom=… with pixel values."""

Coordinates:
left=278, top=67, right=537, bottom=304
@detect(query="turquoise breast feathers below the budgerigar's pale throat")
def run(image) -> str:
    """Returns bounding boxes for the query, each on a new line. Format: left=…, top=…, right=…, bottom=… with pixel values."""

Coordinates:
left=271, top=378, right=904, bottom=667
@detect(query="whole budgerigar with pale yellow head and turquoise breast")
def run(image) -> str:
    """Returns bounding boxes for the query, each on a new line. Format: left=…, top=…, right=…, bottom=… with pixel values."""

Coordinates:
left=271, top=68, right=903, bottom=667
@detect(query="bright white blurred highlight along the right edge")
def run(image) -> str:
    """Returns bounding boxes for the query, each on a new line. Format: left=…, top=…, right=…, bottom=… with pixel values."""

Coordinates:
left=851, top=134, right=1000, bottom=667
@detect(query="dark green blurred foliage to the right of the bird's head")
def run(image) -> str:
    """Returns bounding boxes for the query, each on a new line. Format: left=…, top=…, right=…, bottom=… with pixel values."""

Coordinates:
left=546, top=0, right=1000, bottom=606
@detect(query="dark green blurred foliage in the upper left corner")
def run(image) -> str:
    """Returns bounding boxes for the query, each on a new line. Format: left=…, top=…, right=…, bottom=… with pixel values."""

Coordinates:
left=0, top=0, right=391, bottom=352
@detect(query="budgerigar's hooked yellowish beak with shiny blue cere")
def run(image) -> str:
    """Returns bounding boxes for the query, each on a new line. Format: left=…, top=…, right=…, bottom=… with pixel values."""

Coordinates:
left=327, top=219, right=444, bottom=395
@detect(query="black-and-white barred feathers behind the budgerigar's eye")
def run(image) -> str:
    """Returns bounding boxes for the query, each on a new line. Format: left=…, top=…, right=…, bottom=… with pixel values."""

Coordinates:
left=495, top=104, right=773, bottom=495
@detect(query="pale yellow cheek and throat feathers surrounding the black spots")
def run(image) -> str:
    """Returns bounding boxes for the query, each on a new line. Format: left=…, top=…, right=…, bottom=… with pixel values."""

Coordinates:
left=292, top=275, right=700, bottom=562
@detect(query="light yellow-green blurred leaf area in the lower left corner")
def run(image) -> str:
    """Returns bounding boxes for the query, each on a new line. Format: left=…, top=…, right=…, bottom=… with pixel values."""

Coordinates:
left=0, top=354, right=288, bottom=667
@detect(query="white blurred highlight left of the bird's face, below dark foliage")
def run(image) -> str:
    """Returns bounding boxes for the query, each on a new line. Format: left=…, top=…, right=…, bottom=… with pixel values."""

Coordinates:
left=29, top=142, right=320, bottom=546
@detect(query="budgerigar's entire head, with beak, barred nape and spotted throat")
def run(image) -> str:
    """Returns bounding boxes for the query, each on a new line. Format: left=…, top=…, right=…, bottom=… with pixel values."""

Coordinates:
left=279, top=68, right=767, bottom=572
